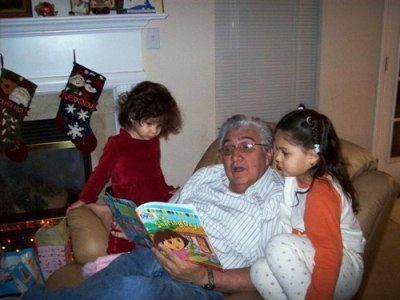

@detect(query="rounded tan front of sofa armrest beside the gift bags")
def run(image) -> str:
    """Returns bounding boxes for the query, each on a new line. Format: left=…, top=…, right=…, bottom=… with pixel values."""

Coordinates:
left=67, top=206, right=108, bottom=265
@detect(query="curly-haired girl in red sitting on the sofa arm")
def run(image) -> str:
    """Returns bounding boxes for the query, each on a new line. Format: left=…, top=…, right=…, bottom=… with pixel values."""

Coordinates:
left=68, top=81, right=182, bottom=254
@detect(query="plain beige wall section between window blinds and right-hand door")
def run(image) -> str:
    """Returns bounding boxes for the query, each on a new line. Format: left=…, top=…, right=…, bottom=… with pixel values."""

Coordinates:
left=319, top=0, right=384, bottom=150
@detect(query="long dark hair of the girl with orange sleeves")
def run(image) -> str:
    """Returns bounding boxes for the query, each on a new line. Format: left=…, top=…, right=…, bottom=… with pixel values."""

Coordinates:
left=275, top=107, right=358, bottom=212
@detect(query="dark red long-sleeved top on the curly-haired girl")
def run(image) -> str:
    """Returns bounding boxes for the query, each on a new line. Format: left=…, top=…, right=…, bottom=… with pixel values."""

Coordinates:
left=79, top=129, right=173, bottom=205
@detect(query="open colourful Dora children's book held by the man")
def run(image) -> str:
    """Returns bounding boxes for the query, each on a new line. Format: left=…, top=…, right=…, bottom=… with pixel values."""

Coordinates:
left=103, top=195, right=223, bottom=271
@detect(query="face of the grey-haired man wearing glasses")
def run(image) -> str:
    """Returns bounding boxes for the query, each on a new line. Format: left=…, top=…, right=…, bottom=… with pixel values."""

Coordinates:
left=221, top=127, right=272, bottom=194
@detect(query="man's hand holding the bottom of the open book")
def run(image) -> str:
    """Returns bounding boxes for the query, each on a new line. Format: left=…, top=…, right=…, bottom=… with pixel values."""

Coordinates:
left=152, top=244, right=208, bottom=286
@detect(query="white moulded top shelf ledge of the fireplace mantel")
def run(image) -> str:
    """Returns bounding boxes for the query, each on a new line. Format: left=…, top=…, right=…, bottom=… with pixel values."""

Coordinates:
left=0, top=13, right=168, bottom=38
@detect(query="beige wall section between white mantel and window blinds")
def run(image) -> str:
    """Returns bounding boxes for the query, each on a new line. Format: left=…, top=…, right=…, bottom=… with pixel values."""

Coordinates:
left=143, top=0, right=216, bottom=185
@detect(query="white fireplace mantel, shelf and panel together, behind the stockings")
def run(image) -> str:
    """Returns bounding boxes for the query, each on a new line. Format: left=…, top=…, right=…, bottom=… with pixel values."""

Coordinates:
left=0, top=14, right=168, bottom=95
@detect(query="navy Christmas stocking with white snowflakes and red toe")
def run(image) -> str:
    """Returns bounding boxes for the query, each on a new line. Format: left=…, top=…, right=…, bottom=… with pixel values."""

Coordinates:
left=56, top=62, right=106, bottom=153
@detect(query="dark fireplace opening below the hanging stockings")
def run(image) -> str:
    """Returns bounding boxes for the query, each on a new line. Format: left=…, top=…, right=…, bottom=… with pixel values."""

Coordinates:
left=0, top=119, right=92, bottom=249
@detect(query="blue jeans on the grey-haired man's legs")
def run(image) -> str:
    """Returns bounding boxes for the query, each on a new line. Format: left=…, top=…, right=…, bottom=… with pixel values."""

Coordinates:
left=21, top=248, right=224, bottom=300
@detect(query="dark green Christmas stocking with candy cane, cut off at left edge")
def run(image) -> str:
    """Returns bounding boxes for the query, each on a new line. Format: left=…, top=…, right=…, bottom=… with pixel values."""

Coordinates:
left=0, top=68, right=37, bottom=162
